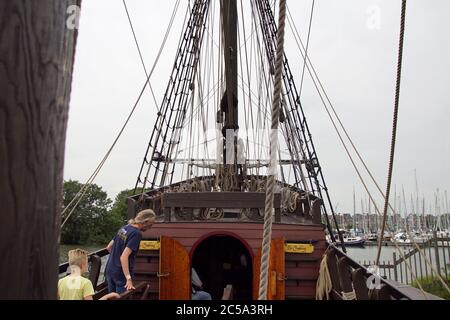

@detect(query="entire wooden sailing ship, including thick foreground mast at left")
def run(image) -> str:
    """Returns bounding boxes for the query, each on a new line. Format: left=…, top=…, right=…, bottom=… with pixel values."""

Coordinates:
left=0, top=0, right=442, bottom=300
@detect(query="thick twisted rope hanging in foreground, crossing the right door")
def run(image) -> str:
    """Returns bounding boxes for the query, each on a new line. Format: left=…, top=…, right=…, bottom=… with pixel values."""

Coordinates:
left=259, top=0, right=286, bottom=300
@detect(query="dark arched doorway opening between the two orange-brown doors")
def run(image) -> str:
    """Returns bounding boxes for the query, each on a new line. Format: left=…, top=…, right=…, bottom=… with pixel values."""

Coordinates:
left=191, top=235, right=253, bottom=300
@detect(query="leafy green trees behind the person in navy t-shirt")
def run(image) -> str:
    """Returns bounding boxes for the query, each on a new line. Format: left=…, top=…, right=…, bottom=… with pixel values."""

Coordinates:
left=61, top=180, right=133, bottom=245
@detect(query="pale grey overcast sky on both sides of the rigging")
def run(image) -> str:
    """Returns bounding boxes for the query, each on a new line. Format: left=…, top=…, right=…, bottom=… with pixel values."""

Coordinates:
left=64, top=0, right=450, bottom=212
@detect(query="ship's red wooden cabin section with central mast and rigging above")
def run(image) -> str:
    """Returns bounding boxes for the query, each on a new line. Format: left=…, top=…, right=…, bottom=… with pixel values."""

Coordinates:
left=110, top=0, right=436, bottom=300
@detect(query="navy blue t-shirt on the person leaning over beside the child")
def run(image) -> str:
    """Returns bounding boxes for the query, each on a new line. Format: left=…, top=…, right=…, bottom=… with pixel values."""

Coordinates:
left=106, top=224, right=142, bottom=274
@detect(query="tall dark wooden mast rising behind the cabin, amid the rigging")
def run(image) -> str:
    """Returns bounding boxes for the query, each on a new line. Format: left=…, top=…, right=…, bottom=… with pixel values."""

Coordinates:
left=218, top=0, right=239, bottom=189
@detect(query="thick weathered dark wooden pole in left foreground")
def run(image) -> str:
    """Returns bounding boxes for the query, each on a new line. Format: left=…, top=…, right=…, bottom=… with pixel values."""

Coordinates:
left=0, top=0, right=81, bottom=299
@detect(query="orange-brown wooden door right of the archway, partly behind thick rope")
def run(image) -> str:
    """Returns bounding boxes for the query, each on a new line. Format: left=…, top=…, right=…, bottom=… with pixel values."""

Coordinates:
left=253, top=238, right=285, bottom=300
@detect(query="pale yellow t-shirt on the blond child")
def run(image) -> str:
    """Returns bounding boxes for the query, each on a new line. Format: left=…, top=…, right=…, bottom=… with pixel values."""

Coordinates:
left=58, top=275, right=95, bottom=300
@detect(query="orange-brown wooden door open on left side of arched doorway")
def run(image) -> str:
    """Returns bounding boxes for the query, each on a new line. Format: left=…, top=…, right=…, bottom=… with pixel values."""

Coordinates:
left=159, top=236, right=191, bottom=300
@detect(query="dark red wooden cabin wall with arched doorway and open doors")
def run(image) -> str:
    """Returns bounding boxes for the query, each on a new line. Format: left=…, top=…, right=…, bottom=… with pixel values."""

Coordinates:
left=135, top=222, right=326, bottom=300
